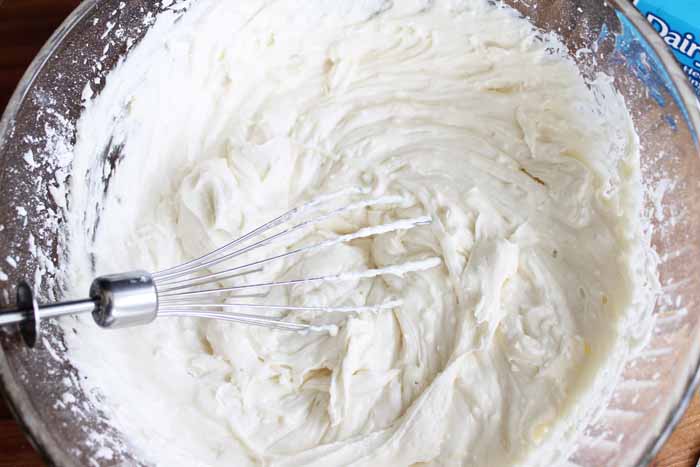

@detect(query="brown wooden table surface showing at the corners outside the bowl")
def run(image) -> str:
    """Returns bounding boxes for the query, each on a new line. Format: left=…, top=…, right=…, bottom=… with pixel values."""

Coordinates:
left=0, top=0, right=700, bottom=467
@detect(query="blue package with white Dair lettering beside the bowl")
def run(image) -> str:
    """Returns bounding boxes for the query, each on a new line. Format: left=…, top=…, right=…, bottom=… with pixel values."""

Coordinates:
left=634, top=0, right=700, bottom=97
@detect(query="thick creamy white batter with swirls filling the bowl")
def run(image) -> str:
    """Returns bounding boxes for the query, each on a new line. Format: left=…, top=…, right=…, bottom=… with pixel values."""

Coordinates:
left=64, top=0, right=650, bottom=467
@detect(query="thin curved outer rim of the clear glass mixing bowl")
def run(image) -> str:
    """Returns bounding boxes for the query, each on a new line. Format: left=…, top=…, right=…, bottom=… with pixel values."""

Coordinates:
left=0, top=0, right=700, bottom=467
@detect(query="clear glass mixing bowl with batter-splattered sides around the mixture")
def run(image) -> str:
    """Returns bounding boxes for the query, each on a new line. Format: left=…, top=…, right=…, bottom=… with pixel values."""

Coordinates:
left=0, top=0, right=700, bottom=467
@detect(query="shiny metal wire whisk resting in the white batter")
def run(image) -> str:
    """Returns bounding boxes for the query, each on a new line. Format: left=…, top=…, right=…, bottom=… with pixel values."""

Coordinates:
left=0, top=189, right=441, bottom=347
